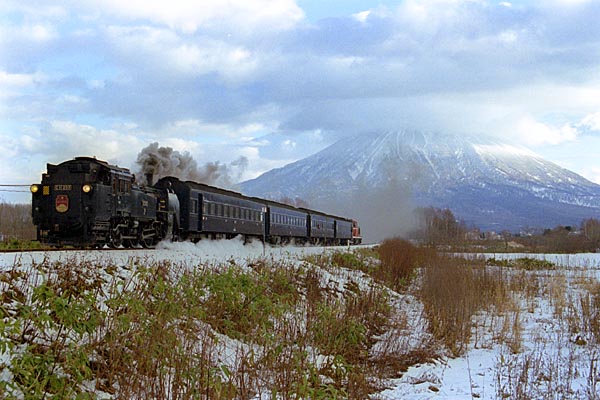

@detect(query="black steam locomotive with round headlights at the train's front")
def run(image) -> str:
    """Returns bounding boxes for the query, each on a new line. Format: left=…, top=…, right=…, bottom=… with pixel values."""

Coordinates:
left=31, top=157, right=160, bottom=247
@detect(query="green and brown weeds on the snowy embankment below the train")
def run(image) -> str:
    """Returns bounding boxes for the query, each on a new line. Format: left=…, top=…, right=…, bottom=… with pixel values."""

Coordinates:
left=0, top=248, right=404, bottom=399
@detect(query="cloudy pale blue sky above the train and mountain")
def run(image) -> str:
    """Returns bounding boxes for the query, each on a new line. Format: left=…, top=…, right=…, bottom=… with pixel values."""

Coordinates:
left=0, top=0, right=600, bottom=202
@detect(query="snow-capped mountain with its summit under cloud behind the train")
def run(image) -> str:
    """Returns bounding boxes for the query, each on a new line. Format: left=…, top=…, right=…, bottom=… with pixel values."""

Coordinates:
left=242, top=130, right=600, bottom=238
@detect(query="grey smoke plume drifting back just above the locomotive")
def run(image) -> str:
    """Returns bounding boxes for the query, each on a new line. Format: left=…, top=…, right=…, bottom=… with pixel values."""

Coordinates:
left=136, top=142, right=248, bottom=189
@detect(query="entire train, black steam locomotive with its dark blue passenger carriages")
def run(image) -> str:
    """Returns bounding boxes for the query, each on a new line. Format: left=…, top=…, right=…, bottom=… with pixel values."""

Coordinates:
left=30, top=157, right=361, bottom=248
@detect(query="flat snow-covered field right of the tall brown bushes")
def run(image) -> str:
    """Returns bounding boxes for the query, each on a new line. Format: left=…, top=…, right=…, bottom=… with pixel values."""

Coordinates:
left=378, top=253, right=600, bottom=400
